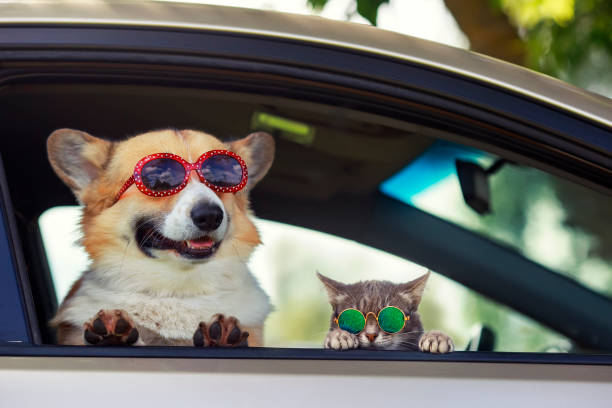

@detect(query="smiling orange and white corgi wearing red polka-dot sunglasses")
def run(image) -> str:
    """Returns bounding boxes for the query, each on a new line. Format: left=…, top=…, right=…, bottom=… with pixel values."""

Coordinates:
left=47, top=129, right=275, bottom=347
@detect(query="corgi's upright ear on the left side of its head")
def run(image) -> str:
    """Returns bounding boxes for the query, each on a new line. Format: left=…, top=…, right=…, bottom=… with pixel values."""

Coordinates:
left=47, top=129, right=112, bottom=203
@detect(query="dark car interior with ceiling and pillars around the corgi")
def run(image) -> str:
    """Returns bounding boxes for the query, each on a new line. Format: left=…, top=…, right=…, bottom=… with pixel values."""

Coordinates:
left=0, top=77, right=612, bottom=352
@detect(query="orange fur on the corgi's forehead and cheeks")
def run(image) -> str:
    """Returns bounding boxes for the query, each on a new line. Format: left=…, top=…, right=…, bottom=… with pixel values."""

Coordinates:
left=67, top=130, right=261, bottom=278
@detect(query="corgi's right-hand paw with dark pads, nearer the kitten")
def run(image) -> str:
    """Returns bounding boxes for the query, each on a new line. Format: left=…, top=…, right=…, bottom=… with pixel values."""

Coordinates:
left=193, top=314, right=249, bottom=347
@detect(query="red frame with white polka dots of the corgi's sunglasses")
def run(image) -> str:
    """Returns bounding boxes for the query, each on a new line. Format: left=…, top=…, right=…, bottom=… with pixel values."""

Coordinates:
left=115, top=150, right=248, bottom=202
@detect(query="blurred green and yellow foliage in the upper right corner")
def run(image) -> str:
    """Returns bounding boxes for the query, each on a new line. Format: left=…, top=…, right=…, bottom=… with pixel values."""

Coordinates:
left=493, top=0, right=612, bottom=92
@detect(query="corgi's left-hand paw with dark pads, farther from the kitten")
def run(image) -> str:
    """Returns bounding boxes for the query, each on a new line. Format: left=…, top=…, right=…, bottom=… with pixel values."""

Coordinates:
left=83, top=309, right=138, bottom=346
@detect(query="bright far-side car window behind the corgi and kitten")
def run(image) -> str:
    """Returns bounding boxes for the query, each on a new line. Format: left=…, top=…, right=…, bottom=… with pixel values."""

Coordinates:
left=39, top=206, right=571, bottom=352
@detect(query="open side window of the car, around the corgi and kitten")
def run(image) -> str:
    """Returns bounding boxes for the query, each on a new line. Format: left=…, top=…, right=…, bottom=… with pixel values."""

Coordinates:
left=0, top=83, right=612, bottom=355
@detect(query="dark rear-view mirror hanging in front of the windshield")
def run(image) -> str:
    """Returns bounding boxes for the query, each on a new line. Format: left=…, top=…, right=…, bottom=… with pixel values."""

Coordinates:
left=455, top=159, right=506, bottom=215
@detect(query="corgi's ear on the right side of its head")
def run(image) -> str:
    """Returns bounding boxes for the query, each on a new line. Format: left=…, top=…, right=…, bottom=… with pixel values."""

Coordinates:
left=229, top=132, right=275, bottom=189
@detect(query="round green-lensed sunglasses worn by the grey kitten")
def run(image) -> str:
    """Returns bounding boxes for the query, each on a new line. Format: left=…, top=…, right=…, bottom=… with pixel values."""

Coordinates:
left=334, top=306, right=410, bottom=334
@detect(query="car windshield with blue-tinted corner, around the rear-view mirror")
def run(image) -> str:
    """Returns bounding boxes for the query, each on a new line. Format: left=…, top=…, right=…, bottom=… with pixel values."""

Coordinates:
left=380, top=141, right=612, bottom=298
